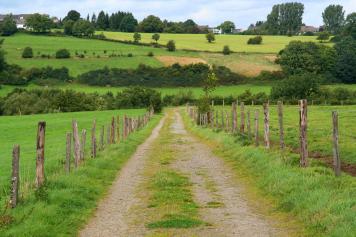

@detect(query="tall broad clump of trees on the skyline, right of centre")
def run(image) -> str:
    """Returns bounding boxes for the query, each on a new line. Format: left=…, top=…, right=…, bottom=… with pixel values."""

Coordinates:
left=266, top=2, right=304, bottom=35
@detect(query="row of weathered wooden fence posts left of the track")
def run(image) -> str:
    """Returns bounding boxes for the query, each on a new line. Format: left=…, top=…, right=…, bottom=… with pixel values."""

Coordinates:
left=5, top=109, right=154, bottom=208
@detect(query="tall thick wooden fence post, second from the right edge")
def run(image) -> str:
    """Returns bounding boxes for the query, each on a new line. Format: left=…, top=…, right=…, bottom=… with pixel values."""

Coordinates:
left=299, top=100, right=308, bottom=167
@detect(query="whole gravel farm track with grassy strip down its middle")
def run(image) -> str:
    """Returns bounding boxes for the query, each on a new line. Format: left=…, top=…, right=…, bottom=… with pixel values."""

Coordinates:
left=80, top=110, right=290, bottom=237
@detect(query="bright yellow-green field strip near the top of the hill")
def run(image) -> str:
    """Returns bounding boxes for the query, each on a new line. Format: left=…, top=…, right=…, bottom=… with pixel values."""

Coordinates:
left=97, top=31, right=328, bottom=53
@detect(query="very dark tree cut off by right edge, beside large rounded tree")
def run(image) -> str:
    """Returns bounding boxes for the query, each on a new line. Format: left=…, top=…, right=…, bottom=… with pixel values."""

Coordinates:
left=335, top=37, right=356, bottom=83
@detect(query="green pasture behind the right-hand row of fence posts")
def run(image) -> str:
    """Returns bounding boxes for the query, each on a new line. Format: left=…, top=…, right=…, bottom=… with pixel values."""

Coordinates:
left=216, top=105, right=356, bottom=165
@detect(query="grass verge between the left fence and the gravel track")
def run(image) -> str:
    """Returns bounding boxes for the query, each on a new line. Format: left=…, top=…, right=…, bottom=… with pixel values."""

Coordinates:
left=0, top=115, right=161, bottom=237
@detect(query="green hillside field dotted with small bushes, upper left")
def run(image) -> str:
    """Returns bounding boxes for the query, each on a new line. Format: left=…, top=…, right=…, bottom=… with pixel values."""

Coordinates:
left=3, top=33, right=197, bottom=76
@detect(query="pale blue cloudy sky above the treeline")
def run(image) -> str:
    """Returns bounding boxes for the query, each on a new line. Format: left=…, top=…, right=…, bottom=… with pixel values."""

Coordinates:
left=0, top=0, right=356, bottom=29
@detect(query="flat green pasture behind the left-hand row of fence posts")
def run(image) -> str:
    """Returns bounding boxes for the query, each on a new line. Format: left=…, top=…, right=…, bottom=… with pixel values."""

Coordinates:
left=0, top=109, right=145, bottom=197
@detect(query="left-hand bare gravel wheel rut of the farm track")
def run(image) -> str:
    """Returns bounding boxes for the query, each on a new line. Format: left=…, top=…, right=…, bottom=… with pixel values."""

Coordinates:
left=79, top=116, right=164, bottom=237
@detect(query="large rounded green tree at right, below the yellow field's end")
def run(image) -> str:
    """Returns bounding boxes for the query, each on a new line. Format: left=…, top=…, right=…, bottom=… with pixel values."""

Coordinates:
left=277, top=41, right=336, bottom=76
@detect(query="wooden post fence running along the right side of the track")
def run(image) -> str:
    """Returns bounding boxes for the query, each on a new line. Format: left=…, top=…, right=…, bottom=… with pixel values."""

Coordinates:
left=186, top=100, right=356, bottom=176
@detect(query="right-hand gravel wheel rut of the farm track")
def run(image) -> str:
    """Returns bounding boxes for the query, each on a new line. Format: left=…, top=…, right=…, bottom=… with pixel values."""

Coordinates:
left=171, top=113, right=289, bottom=237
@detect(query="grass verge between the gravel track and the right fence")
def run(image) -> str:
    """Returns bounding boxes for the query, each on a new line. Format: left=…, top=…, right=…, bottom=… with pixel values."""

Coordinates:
left=183, top=109, right=356, bottom=237
